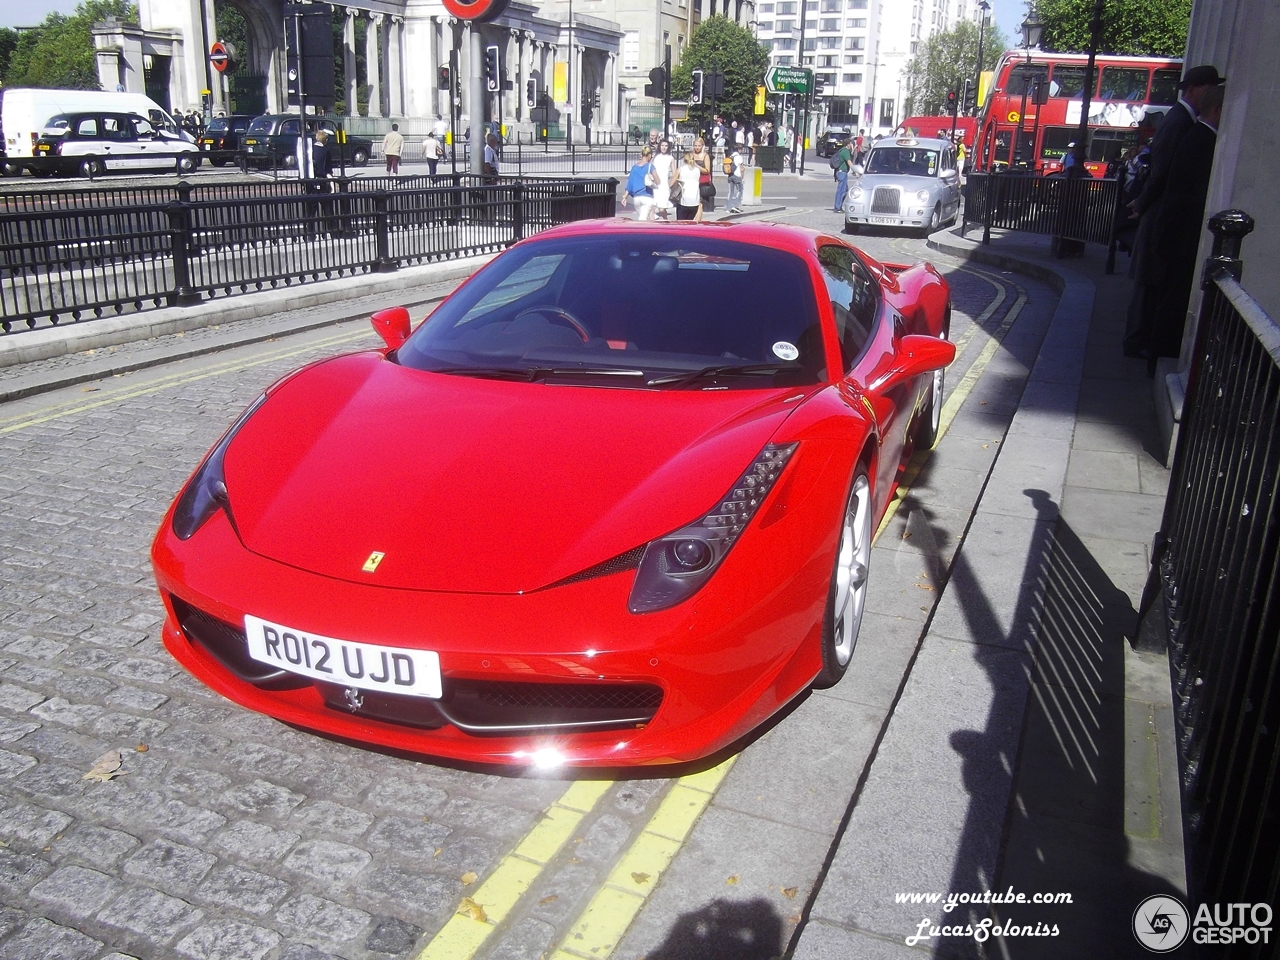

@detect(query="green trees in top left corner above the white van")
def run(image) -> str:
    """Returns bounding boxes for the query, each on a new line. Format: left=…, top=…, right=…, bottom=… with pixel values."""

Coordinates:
left=0, top=0, right=138, bottom=90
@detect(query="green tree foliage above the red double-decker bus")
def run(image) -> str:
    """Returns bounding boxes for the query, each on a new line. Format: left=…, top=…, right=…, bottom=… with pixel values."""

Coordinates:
left=1036, top=0, right=1192, bottom=56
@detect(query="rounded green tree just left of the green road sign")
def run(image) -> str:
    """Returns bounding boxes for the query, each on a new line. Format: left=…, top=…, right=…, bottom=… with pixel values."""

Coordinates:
left=671, top=17, right=769, bottom=125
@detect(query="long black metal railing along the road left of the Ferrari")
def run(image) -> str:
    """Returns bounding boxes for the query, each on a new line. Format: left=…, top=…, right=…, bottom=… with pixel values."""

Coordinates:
left=0, top=175, right=617, bottom=333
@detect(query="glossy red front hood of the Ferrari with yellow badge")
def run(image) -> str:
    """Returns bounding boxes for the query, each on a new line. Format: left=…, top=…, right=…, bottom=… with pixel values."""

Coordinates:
left=218, top=353, right=800, bottom=594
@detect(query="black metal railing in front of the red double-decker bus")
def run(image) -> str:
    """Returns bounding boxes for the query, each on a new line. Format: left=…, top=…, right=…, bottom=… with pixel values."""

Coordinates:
left=960, top=173, right=1121, bottom=273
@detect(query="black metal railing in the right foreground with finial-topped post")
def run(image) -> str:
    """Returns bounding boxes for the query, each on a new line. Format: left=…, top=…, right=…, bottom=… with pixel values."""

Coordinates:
left=1140, top=210, right=1280, bottom=942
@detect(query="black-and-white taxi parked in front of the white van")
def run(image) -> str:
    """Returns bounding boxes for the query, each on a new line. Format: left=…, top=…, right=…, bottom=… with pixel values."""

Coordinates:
left=27, top=111, right=200, bottom=177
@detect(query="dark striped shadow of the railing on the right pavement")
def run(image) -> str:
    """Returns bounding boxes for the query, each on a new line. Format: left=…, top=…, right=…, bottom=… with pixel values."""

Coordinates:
left=934, top=490, right=1190, bottom=960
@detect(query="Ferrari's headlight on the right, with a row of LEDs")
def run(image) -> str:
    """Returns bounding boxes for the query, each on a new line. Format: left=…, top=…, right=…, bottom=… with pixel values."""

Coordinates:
left=627, top=443, right=799, bottom=613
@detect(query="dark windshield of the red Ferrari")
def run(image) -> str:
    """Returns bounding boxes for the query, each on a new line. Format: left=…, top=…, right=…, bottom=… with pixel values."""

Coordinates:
left=397, top=230, right=826, bottom=389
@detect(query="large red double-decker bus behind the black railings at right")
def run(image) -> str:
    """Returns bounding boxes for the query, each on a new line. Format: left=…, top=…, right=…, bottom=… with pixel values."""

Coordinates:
left=973, top=50, right=1183, bottom=177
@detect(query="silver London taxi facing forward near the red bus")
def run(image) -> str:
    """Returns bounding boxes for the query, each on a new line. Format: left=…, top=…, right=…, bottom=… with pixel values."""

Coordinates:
left=845, top=137, right=960, bottom=236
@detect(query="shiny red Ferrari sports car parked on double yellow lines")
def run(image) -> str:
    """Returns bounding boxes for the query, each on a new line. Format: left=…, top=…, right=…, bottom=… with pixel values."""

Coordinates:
left=152, top=221, right=955, bottom=767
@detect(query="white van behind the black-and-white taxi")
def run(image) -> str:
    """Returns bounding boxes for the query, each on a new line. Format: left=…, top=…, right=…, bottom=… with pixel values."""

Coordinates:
left=0, top=87, right=196, bottom=177
